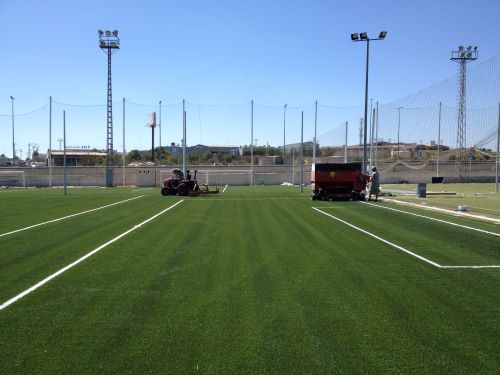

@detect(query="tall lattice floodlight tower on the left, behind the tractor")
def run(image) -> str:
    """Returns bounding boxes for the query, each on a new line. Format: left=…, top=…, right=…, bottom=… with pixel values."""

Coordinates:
left=97, top=30, right=120, bottom=187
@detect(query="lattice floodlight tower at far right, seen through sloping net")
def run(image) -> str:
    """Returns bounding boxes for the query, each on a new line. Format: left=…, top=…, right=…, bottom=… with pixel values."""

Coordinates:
left=450, top=46, right=478, bottom=178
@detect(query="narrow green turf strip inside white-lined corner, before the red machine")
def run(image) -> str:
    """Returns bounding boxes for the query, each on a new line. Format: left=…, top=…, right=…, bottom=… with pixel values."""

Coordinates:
left=316, top=202, right=500, bottom=265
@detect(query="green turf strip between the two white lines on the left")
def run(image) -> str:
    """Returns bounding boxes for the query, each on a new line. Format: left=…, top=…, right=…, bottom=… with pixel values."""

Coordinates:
left=0, top=197, right=184, bottom=300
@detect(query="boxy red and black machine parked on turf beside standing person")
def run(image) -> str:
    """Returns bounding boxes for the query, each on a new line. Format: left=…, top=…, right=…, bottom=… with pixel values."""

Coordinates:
left=311, top=163, right=369, bottom=200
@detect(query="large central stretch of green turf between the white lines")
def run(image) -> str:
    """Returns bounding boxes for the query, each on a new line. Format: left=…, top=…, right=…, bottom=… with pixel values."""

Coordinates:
left=0, top=189, right=500, bottom=373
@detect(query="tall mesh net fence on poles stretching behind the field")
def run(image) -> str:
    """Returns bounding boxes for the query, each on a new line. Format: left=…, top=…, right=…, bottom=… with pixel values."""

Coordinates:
left=0, top=55, right=500, bottom=164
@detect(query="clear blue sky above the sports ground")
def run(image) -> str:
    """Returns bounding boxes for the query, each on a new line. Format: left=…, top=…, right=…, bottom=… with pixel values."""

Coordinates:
left=0, top=0, right=500, bottom=156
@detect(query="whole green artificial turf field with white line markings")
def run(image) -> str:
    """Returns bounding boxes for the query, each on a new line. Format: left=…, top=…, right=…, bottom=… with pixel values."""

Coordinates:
left=0, top=186, right=500, bottom=374
